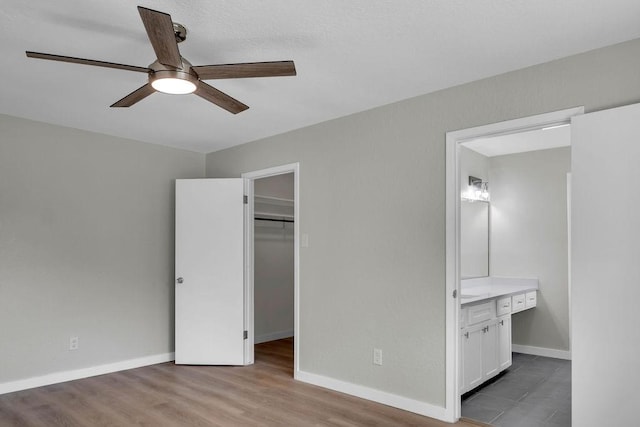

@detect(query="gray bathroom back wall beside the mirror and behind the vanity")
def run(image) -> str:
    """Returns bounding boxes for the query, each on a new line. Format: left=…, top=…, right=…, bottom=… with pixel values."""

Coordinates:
left=490, top=147, right=571, bottom=350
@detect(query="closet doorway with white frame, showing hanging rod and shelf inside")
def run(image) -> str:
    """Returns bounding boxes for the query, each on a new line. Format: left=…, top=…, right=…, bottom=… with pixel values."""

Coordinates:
left=242, top=164, right=299, bottom=376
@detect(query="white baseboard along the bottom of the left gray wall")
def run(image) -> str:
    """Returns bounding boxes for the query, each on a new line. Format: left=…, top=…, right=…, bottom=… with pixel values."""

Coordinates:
left=0, top=353, right=175, bottom=394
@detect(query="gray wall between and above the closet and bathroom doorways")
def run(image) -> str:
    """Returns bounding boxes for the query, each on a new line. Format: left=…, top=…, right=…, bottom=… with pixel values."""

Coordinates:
left=207, top=40, right=640, bottom=406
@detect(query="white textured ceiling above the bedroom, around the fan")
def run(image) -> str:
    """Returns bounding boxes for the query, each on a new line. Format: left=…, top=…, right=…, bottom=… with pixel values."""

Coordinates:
left=0, top=0, right=640, bottom=152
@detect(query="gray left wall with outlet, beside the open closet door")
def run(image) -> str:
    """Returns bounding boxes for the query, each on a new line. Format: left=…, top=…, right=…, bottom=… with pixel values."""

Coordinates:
left=0, top=115, right=205, bottom=383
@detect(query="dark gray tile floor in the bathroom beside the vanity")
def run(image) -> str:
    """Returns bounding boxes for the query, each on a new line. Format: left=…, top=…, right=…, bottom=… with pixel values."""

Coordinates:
left=462, top=353, right=571, bottom=427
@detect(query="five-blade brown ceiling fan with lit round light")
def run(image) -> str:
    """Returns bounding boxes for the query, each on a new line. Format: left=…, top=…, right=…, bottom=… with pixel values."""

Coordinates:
left=26, top=6, right=296, bottom=114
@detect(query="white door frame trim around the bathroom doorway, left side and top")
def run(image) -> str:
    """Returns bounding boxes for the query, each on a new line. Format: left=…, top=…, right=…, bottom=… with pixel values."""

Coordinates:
left=445, top=107, right=584, bottom=422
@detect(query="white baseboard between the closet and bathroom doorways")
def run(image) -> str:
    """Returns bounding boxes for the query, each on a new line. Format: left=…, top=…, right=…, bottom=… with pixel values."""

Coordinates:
left=294, top=371, right=444, bottom=422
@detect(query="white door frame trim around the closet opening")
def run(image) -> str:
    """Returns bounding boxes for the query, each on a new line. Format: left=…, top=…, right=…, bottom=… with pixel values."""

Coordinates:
left=242, top=163, right=300, bottom=376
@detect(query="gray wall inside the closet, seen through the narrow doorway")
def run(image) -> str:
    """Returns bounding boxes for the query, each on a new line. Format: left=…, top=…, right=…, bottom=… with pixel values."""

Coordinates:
left=254, top=173, right=294, bottom=343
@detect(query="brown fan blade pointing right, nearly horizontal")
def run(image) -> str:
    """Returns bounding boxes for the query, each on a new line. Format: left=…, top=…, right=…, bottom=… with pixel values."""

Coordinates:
left=191, top=61, right=296, bottom=80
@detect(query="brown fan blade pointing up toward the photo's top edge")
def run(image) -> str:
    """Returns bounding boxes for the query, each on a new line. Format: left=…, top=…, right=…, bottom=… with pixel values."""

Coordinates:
left=138, top=6, right=182, bottom=68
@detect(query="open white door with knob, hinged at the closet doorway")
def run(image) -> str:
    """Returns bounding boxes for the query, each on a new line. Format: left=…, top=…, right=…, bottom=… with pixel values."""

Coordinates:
left=175, top=178, right=245, bottom=365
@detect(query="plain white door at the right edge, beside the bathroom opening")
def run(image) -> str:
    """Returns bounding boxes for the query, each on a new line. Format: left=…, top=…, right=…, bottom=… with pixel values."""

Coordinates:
left=571, top=104, right=640, bottom=426
